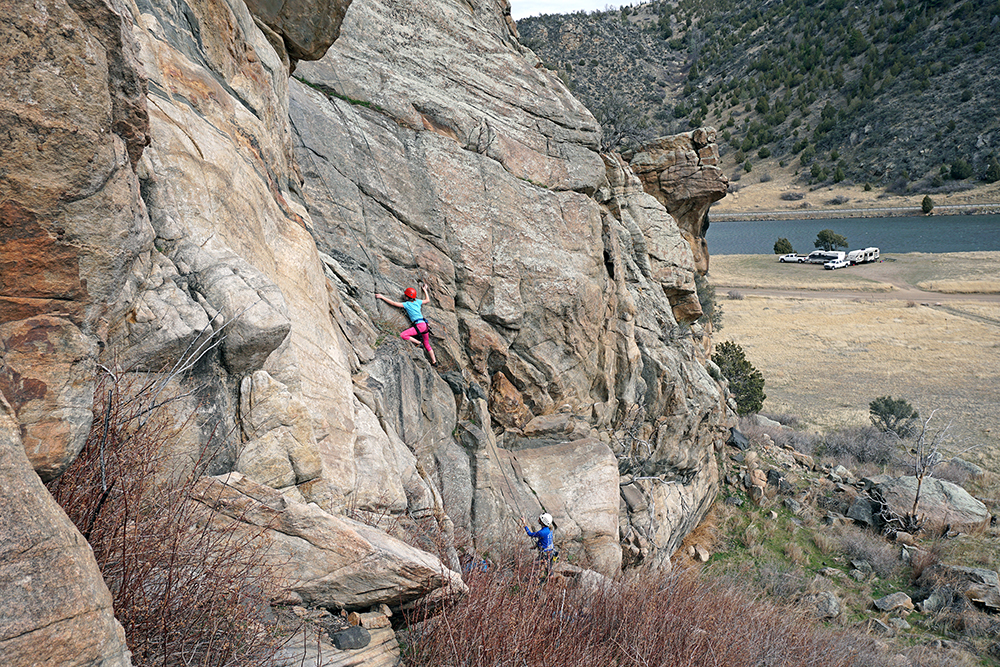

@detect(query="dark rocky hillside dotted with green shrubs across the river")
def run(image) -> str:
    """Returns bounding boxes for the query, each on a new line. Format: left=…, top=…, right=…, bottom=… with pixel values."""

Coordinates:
left=518, top=0, right=1000, bottom=204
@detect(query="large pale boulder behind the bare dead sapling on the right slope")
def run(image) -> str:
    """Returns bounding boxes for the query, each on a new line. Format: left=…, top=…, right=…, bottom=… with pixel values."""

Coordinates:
left=868, top=475, right=990, bottom=531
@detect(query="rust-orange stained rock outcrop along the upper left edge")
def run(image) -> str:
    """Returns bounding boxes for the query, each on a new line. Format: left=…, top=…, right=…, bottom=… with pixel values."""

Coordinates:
left=0, top=0, right=152, bottom=478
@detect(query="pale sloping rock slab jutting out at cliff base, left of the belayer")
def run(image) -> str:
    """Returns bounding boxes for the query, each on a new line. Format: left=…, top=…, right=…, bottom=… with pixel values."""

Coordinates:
left=193, top=473, right=467, bottom=609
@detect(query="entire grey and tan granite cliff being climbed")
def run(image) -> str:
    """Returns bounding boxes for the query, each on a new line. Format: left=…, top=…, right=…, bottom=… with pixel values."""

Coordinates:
left=0, top=0, right=731, bottom=665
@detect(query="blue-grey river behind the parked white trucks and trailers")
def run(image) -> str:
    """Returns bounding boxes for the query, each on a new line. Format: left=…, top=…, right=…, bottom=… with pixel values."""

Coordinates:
left=705, top=215, right=1000, bottom=255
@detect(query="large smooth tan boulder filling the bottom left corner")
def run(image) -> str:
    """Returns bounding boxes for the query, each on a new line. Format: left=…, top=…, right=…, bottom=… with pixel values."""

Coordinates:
left=0, top=396, right=131, bottom=667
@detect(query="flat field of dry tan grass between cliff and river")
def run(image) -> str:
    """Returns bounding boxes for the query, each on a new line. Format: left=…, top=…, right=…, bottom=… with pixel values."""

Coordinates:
left=709, top=253, right=1000, bottom=472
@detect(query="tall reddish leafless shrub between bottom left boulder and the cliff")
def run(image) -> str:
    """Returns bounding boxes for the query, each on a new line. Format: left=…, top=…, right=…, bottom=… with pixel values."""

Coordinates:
left=49, top=374, right=288, bottom=667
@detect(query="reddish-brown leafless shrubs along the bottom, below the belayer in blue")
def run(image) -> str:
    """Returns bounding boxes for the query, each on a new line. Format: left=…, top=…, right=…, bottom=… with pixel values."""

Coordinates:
left=403, top=557, right=887, bottom=667
